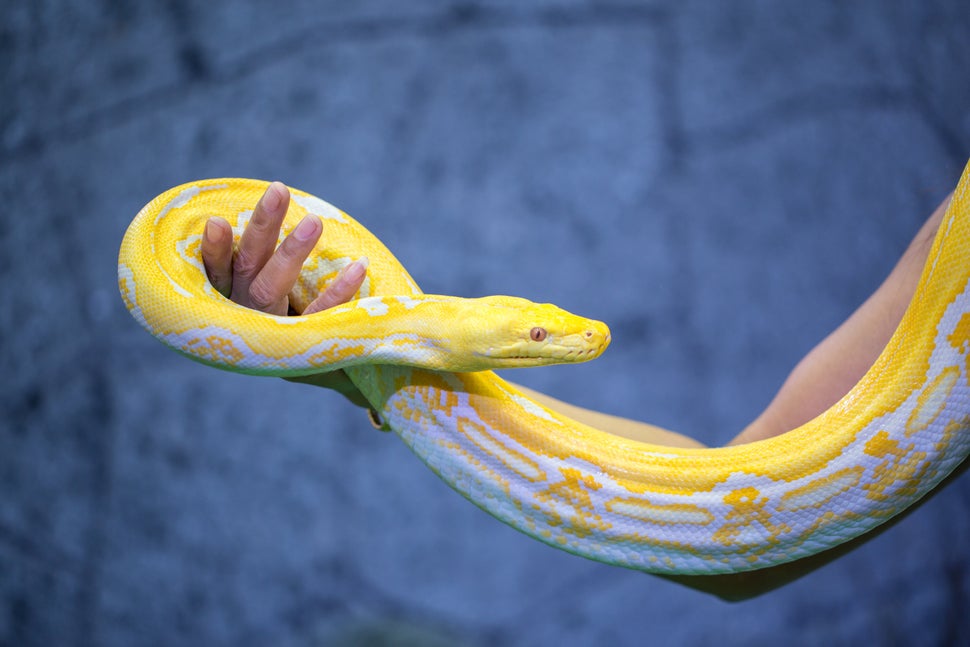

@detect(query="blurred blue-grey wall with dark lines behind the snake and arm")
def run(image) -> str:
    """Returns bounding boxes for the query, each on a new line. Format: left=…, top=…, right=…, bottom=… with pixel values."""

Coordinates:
left=0, top=0, right=970, bottom=646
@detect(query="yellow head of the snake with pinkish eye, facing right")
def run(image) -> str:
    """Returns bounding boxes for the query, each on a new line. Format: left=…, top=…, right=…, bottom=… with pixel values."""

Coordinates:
left=460, top=296, right=610, bottom=368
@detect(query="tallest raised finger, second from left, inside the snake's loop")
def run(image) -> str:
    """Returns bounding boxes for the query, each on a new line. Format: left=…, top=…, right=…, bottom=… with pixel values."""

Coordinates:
left=230, top=182, right=292, bottom=314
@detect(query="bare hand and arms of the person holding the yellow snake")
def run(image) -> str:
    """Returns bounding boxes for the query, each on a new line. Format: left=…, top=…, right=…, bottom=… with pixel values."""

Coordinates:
left=202, top=182, right=950, bottom=599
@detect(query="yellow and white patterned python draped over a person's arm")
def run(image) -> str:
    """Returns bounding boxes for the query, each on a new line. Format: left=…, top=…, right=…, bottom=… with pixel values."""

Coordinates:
left=118, top=166, right=970, bottom=576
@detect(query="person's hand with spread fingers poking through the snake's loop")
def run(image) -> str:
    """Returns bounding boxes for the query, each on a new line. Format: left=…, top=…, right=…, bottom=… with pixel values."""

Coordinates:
left=202, top=182, right=370, bottom=407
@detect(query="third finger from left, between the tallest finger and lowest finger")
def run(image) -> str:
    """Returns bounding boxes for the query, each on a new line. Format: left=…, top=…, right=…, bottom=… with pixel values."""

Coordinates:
left=249, top=215, right=323, bottom=315
